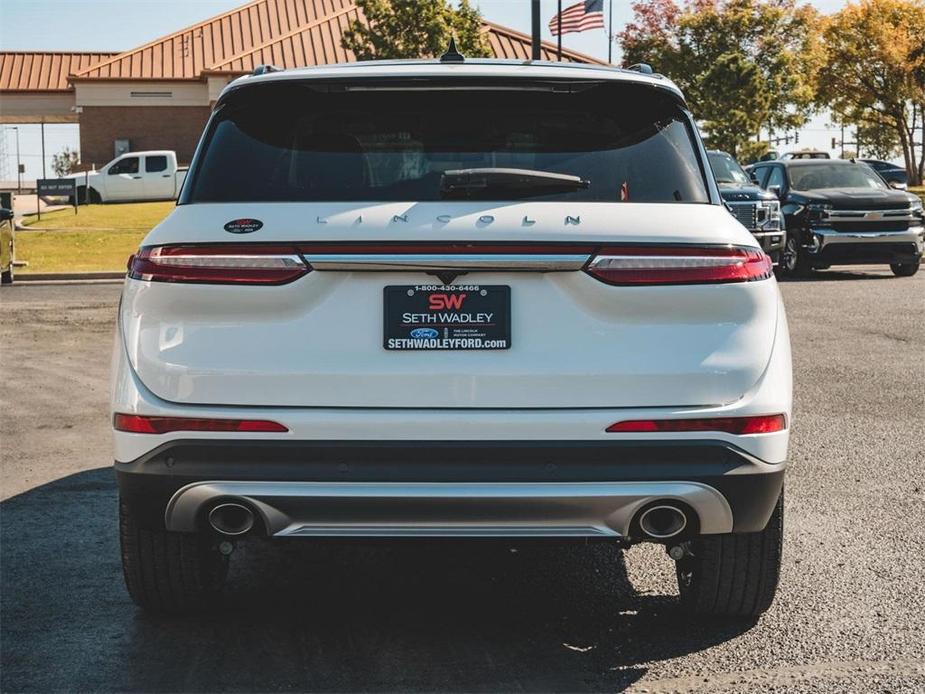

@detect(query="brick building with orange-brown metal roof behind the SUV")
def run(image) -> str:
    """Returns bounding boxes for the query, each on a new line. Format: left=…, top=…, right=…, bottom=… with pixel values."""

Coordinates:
left=0, top=0, right=599, bottom=171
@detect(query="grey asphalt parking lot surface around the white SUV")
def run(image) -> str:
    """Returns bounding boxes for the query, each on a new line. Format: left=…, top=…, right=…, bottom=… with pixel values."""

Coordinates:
left=0, top=268, right=925, bottom=692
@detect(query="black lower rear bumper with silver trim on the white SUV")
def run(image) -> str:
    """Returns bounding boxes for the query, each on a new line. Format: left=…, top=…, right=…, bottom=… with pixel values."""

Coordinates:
left=116, top=440, right=784, bottom=537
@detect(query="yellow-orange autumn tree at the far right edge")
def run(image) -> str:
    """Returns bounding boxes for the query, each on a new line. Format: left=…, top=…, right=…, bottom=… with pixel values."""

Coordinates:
left=819, top=0, right=925, bottom=185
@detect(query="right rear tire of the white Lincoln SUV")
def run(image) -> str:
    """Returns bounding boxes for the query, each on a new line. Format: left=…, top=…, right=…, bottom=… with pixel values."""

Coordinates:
left=676, top=490, right=784, bottom=619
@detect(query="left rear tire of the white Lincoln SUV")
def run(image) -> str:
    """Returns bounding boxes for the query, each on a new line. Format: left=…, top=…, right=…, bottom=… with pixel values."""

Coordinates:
left=119, top=501, right=228, bottom=614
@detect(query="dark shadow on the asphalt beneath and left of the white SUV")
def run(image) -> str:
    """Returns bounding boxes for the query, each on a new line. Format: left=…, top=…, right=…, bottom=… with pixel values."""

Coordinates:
left=0, top=468, right=748, bottom=691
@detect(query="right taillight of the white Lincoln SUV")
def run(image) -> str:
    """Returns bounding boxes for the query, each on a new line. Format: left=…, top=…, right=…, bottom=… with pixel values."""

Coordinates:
left=585, top=246, right=772, bottom=285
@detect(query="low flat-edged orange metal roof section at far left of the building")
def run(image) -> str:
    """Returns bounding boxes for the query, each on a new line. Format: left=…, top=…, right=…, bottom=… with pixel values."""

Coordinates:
left=0, top=51, right=118, bottom=92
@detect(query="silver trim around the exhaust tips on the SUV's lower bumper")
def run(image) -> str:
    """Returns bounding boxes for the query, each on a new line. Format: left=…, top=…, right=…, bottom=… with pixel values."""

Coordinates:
left=164, top=481, right=733, bottom=537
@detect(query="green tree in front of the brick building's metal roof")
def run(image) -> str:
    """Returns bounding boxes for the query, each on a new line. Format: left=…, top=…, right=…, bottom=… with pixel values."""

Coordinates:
left=341, top=0, right=491, bottom=60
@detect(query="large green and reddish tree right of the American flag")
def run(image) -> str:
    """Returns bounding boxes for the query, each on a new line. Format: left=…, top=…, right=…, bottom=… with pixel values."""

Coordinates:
left=619, top=0, right=823, bottom=159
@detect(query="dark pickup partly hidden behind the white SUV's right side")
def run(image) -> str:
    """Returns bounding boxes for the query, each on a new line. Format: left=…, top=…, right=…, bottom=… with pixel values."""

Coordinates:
left=707, top=150, right=784, bottom=265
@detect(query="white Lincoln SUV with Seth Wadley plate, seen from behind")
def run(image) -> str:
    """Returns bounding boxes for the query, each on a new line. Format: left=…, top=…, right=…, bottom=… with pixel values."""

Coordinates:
left=112, top=60, right=791, bottom=618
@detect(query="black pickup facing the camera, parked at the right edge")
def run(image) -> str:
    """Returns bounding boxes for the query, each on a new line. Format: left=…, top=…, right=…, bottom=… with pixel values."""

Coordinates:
left=749, top=159, right=925, bottom=277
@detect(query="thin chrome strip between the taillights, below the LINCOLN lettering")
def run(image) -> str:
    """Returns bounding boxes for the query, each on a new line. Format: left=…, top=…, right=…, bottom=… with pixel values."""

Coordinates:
left=305, top=253, right=591, bottom=272
